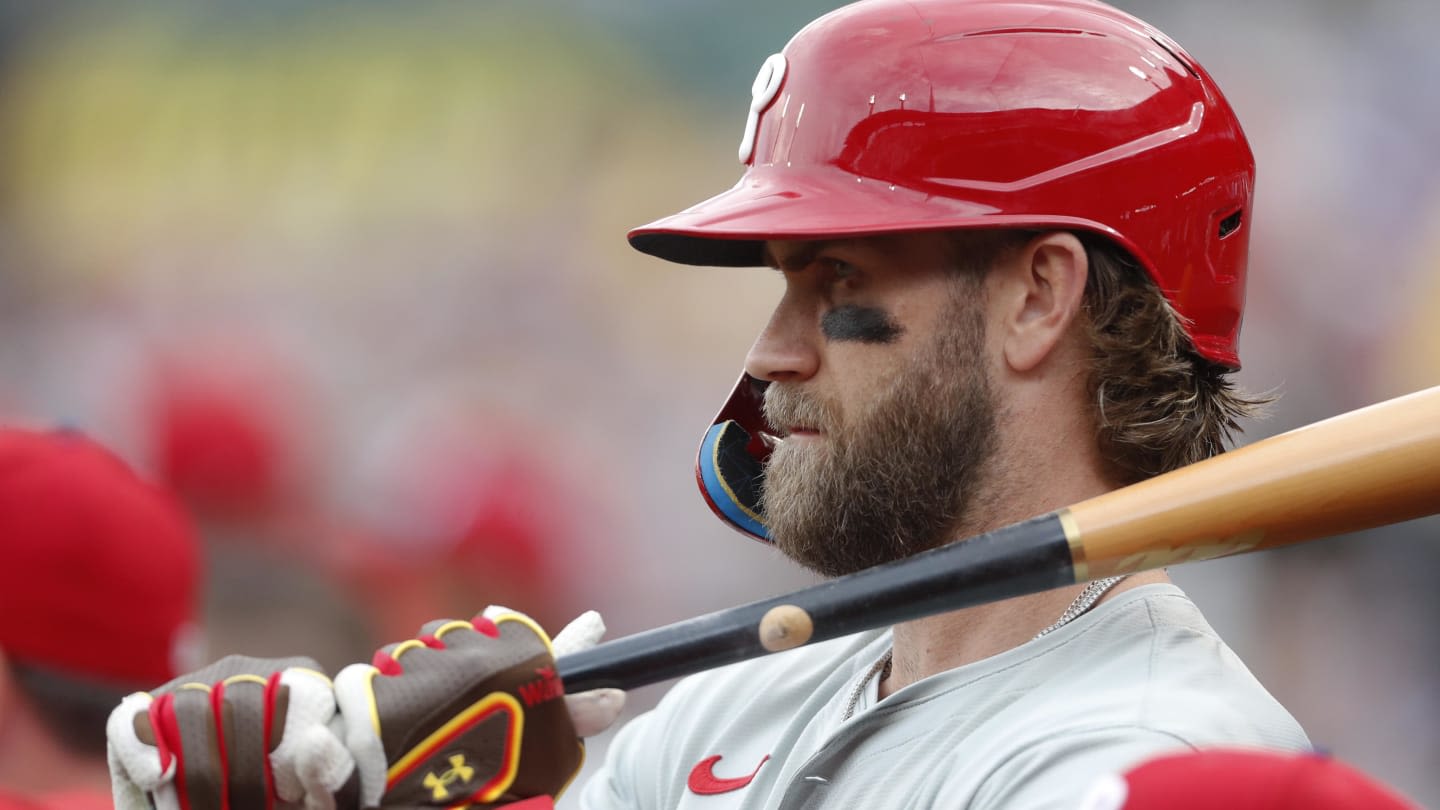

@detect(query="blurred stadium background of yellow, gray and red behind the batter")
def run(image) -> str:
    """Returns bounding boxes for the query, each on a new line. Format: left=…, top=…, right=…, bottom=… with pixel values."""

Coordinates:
left=0, top=0, right=1440, bottom=806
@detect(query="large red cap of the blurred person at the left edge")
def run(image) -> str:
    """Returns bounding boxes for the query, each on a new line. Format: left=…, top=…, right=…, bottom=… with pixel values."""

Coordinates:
left=0, top=430, right=200, bottom=686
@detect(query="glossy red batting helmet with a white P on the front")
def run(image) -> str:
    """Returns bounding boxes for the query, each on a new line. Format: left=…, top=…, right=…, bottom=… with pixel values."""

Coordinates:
left=629, top=0, right=1254, bottom=536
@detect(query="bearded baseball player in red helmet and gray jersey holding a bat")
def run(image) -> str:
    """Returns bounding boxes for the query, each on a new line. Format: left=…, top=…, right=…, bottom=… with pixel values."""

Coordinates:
left=109, top=0, right=1308, bottom=810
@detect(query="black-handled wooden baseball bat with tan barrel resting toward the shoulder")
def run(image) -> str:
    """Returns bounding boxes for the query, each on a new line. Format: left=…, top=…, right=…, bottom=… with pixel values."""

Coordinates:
left=557, top=386, right=1440, bottom=692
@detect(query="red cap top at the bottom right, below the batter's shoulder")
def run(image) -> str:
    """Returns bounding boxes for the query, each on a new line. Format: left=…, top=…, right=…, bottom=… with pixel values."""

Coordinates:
left=1081, top=749, right=1418, bottom=810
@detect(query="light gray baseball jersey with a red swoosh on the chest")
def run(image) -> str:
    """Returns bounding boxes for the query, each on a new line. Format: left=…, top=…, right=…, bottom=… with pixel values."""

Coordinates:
left=580, top=585, right=1309, bottom=810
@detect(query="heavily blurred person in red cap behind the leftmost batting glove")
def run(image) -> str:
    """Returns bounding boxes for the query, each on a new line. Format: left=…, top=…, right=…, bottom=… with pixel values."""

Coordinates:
left=131, top=337, right=386, bottom=667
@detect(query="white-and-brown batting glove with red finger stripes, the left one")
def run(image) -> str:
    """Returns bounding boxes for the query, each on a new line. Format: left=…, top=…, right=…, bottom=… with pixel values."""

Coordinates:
left=105, top=656, right=357, bottom=810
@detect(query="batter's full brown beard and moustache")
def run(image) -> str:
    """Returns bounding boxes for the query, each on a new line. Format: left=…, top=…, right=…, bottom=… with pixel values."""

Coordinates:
left=762, top=292, right=995, bottom=577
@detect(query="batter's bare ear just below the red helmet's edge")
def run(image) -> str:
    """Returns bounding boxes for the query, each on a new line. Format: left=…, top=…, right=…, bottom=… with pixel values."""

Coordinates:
left=989, top=231, right=1090, bottom=373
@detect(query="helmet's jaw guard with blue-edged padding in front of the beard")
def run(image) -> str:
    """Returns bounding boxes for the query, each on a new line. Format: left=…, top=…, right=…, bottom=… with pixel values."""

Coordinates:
left=696, top=375, right=773, bottom=543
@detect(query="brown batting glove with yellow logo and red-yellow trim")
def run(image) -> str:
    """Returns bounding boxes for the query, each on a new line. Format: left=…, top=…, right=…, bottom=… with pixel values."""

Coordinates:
left=336, top=607, right=619, bottom=809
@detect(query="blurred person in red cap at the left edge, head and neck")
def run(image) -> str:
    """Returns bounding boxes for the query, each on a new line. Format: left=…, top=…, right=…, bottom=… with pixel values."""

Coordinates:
left=0, top=428, right=200, bottom=810
